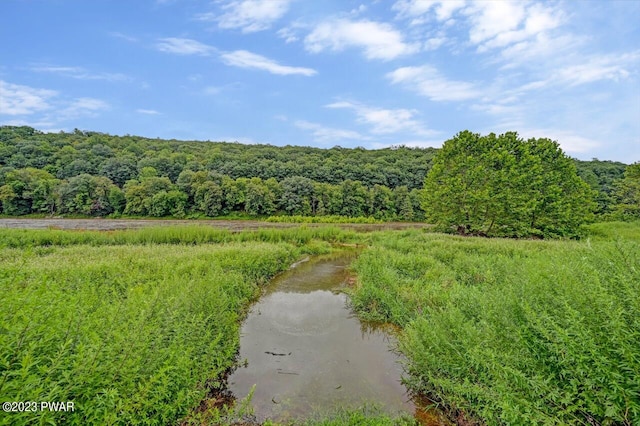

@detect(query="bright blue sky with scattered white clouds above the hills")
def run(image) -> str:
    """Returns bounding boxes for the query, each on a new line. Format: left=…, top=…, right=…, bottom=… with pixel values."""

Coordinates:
left=0, top=0, right=640, bottom=163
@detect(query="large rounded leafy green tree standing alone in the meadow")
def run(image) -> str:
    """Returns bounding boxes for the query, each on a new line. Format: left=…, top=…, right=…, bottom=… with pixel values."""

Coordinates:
left=422, top=131, right=595, bottom=237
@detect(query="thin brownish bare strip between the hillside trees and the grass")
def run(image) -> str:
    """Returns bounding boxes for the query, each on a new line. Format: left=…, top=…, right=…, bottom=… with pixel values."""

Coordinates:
left=0, top=218, right=429, bottom=232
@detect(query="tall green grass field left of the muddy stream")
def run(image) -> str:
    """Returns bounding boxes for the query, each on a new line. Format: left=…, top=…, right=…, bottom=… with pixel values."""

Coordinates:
left=0, top=240, right=310, bottom=425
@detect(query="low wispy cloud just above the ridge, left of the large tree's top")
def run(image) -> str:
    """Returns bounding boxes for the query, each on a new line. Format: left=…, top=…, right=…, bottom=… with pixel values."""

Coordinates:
left=326, top=101, right=432, bottom=135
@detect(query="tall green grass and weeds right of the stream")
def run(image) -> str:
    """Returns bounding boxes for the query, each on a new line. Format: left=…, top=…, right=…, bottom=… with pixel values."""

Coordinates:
left=351, top=223, right=640, bottom=425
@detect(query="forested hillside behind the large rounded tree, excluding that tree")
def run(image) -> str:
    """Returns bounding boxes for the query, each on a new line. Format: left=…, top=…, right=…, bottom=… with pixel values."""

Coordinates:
left=0, top=126, right=632, bottom=220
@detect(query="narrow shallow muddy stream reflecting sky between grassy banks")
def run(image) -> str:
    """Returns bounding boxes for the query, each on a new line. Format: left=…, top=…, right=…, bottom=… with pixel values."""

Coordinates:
left=229, top=253, right=414, bottom=421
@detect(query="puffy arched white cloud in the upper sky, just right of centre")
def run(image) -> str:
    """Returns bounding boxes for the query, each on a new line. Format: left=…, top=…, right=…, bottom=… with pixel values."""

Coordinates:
left=304, top=19, right=419, bottom=60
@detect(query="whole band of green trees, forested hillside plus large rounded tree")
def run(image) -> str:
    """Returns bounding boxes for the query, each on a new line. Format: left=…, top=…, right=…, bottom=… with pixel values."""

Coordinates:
left=0, top=126, right=640, bottom=230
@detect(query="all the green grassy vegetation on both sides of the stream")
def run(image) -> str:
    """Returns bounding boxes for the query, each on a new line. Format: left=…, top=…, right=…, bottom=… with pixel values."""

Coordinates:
left=0, top=222, right=640, bottom=425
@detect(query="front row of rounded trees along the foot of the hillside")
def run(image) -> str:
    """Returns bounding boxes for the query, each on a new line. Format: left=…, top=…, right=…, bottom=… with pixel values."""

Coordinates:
left=0, top=167, right=424, bottom=220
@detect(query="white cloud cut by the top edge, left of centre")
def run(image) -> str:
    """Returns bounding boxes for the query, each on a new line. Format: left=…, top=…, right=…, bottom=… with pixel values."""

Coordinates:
left=204, top=0, right=291, bottom=33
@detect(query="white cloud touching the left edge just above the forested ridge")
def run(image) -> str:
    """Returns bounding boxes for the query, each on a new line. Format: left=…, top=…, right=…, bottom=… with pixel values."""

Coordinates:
left=0, top=80, right=58, bottom=115
